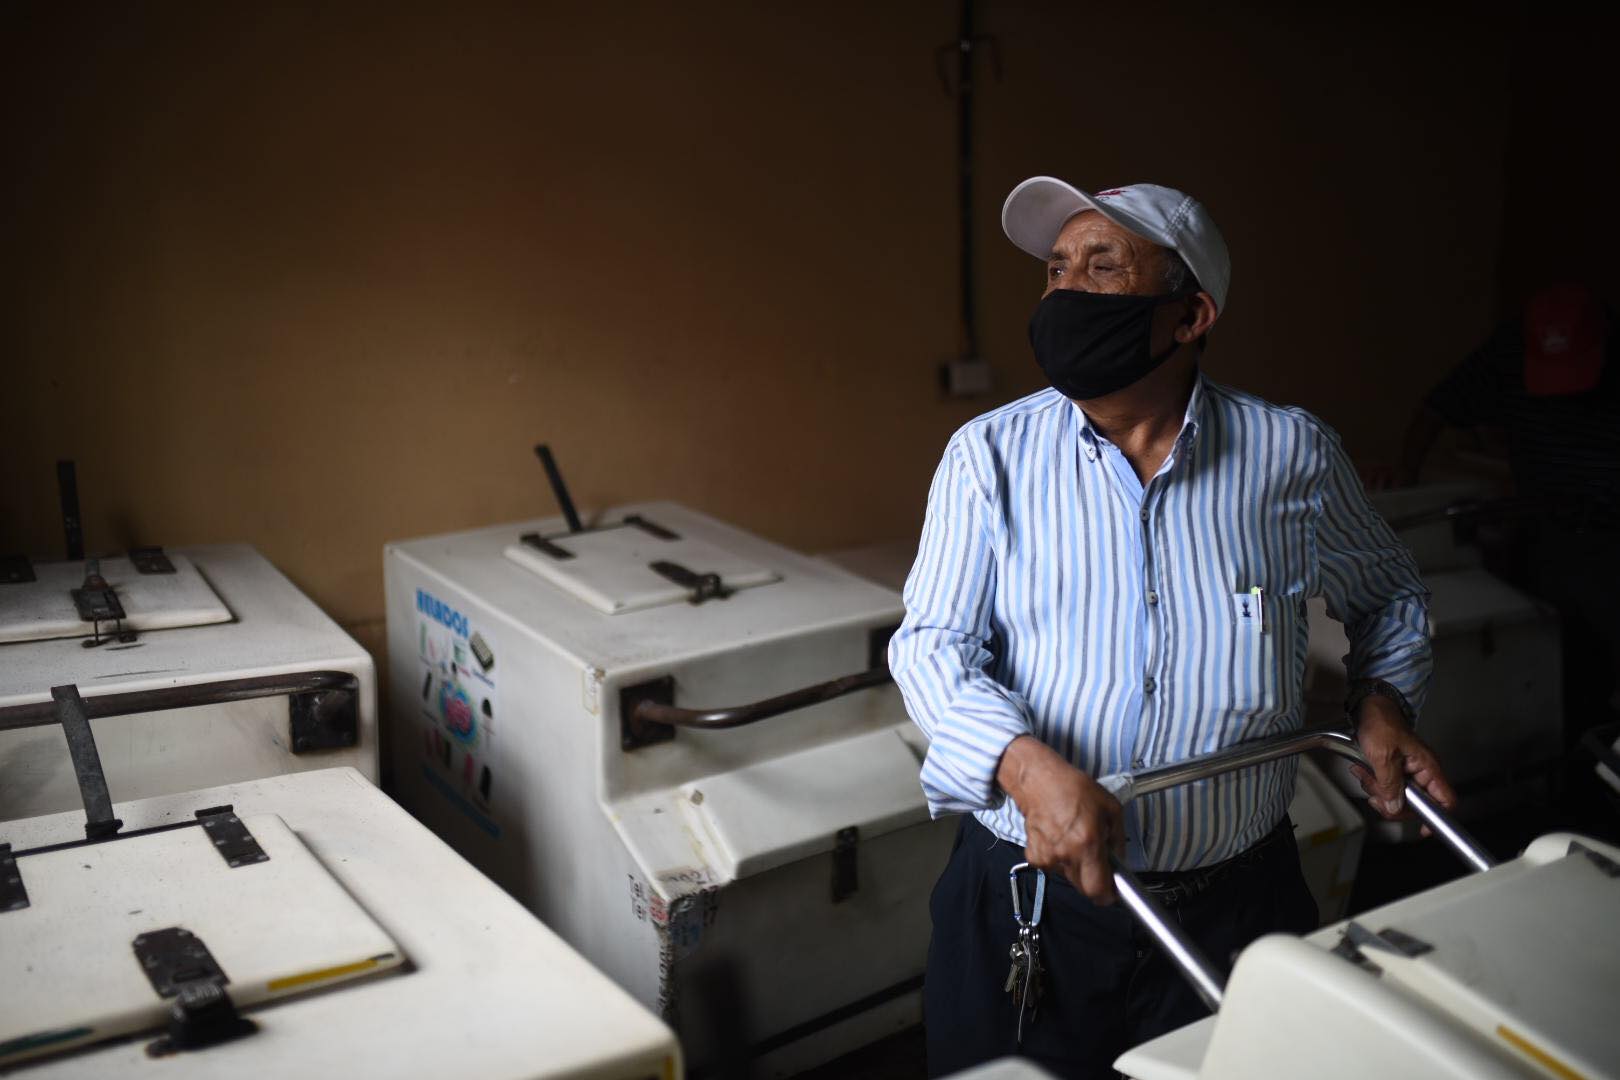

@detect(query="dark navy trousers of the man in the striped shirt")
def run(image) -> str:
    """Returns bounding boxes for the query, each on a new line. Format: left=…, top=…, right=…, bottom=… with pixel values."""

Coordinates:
left=923, top=816, right=1317, bottom=1078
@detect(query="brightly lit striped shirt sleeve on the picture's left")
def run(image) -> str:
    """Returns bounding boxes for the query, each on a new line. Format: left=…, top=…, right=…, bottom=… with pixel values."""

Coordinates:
left=889, top=440, right=1030, bottom=818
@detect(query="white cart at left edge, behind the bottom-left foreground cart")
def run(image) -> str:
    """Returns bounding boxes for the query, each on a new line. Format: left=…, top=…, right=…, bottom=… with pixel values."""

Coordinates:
left=0, top=544, right=377, bottom=821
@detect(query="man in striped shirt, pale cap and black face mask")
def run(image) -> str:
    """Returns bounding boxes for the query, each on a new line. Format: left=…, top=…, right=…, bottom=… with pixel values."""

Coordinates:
left=889, top=176, right=1452, bottom=1077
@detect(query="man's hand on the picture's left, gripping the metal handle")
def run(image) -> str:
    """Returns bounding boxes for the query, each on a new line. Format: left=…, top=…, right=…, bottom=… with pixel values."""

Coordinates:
left=996, top=735, right=1124, bottom=904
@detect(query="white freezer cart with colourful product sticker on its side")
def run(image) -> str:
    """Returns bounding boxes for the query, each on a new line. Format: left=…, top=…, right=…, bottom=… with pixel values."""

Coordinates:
left=384, top=504, right=954, bottom=1075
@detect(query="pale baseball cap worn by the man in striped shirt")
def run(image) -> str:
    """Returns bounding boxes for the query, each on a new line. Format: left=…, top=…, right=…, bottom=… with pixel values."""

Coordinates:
left=1001, top=176, right=1231, bottom=311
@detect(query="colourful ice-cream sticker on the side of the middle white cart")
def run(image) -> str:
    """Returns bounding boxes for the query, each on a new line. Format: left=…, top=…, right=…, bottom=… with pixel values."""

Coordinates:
left=416, top=589, right=502, bottom=837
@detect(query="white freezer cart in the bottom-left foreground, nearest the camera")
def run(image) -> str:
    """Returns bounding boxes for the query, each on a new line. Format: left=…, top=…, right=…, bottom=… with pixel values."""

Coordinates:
left=0, top=767, right=682, bottom=1080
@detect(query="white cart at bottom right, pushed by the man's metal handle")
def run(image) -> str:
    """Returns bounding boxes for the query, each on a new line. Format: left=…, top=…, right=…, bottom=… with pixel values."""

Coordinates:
left=1116, top=834, right=1620, bottom=1080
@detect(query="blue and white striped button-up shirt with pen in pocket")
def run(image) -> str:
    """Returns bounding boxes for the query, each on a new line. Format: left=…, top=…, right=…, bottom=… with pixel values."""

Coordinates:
left=889, top=376, right=1430, bottom=870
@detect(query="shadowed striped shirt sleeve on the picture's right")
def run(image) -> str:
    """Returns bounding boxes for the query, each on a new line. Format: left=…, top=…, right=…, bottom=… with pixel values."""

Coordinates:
left=1315, top=427, right=1434, bottom=716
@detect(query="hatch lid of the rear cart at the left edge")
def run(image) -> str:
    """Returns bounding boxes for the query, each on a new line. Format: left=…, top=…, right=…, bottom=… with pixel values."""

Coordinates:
left=0, top=552, right=232, bottom=644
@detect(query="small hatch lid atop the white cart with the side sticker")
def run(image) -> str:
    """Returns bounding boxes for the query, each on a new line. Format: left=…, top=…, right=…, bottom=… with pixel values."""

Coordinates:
left=504, top=518, right=781, bottom=615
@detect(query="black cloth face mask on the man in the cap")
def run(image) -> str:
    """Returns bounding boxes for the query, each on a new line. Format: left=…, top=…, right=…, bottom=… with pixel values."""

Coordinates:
left=1029, top=288, right=1191, bottom=402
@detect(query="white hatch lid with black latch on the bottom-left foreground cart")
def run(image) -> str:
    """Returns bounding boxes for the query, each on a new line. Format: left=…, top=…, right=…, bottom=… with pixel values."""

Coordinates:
left=0, top=814, right=402, bottom=1069
